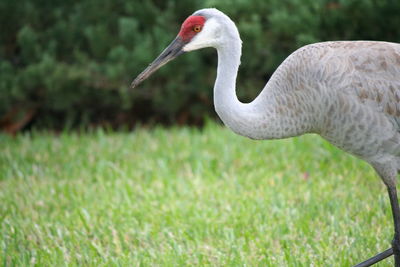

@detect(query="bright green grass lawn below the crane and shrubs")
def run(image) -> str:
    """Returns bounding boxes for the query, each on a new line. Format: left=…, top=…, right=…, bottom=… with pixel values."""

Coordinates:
left=0, top=123, right=393, bottom=266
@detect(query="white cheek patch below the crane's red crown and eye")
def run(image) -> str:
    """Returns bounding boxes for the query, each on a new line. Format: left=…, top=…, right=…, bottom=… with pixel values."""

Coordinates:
left=182, top=19, right=218, bottom=52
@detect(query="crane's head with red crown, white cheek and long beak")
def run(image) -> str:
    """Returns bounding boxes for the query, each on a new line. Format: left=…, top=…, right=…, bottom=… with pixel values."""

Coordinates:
left=131, top=8, right=241, bottom=88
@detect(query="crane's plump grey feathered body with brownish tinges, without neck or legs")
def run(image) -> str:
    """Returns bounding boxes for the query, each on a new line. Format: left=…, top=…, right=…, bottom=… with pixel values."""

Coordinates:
left=254, top=41, right=400, bottom=182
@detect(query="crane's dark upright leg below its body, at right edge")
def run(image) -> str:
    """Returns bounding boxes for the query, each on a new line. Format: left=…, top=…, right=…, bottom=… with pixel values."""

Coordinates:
left=386, top=183, right=400, bottom=267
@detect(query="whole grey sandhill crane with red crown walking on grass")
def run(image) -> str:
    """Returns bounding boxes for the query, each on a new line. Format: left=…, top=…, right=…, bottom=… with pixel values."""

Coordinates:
left=130, top=8, right=400, bottom=267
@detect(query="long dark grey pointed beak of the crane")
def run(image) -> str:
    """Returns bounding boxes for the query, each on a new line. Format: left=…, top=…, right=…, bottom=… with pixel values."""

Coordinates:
left=130, top=36, right=186, bottom=89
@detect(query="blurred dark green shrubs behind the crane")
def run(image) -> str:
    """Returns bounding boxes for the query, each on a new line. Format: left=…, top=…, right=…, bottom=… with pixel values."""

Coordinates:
left=0, top=0, right=400, bottom=133
